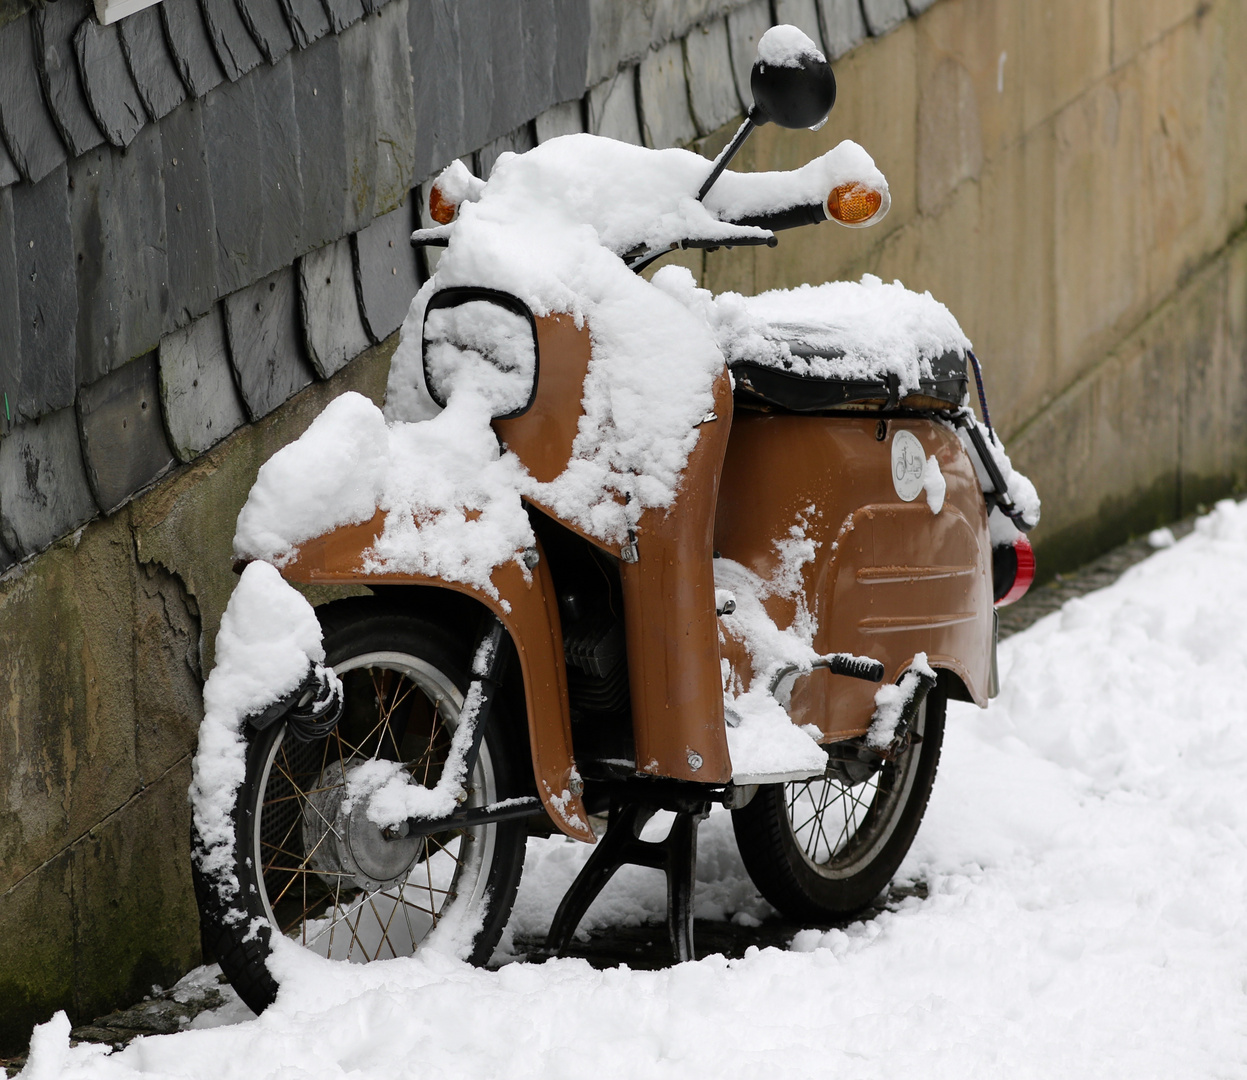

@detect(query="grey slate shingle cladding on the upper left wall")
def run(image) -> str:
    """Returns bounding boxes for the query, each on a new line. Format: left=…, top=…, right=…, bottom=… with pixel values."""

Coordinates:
left=0, top=0, right=930, bottom=569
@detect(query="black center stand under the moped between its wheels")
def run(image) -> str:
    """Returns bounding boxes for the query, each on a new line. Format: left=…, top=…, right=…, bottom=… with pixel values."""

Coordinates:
left=546, top=802, right=710, bottom=963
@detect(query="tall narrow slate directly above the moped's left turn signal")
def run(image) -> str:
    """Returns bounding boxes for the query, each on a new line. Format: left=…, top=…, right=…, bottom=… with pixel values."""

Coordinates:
left=411, top=0, right=475, bottom=180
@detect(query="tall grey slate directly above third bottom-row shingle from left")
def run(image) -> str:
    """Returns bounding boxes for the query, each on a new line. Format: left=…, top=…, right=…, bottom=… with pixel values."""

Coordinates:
left=160, top=101, right=217, bottom=332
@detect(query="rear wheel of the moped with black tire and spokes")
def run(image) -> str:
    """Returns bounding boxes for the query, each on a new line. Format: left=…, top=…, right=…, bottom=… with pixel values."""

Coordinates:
left=732, top=686, right=948, bottom=923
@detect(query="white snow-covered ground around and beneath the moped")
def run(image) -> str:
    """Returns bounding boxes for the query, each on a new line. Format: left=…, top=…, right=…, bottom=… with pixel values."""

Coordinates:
left=22, top=503, right=1247, bottom=1080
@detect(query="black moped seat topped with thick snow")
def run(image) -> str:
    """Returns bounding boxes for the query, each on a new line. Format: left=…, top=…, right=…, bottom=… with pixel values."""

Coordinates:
left=653, top=267, right=970, bottom=413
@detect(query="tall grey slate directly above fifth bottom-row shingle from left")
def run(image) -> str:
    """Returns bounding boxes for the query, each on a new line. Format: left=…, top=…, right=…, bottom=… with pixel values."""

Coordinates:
left=291, top=35, right=349, bottom=248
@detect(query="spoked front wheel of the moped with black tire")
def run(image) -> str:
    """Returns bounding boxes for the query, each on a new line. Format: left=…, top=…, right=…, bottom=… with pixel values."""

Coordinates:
left=196, top=601, right=526, bottom=1013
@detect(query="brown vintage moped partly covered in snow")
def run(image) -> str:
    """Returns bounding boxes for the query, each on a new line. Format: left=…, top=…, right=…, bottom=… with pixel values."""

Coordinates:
left=197, top=27, right=1036, bottom=1009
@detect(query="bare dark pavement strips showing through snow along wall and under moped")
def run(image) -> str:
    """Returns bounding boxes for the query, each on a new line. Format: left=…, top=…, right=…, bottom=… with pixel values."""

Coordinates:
left=0, top=518, right=1195, bottom=1076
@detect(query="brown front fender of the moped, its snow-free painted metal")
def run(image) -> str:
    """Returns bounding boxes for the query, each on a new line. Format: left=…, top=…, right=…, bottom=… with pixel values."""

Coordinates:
left=282, top=510, right=594, bottom=843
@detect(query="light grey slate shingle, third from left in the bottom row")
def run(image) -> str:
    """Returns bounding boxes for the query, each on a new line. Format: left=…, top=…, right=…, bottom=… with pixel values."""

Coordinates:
left=160, top=300, right=247, bottom=461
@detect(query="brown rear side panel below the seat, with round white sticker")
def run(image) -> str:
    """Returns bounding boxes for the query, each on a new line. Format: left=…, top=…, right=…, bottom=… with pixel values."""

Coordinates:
left=715, top=412, right=993, bottom=741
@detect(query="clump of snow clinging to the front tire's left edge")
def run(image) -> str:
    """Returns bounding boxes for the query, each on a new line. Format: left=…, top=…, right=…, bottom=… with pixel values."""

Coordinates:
left=191, top=562, right=337, bottom=900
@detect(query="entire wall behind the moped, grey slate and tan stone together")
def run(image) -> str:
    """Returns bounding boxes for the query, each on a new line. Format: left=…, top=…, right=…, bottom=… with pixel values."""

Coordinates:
left=0, top=0, right=1247, bottom=1050
